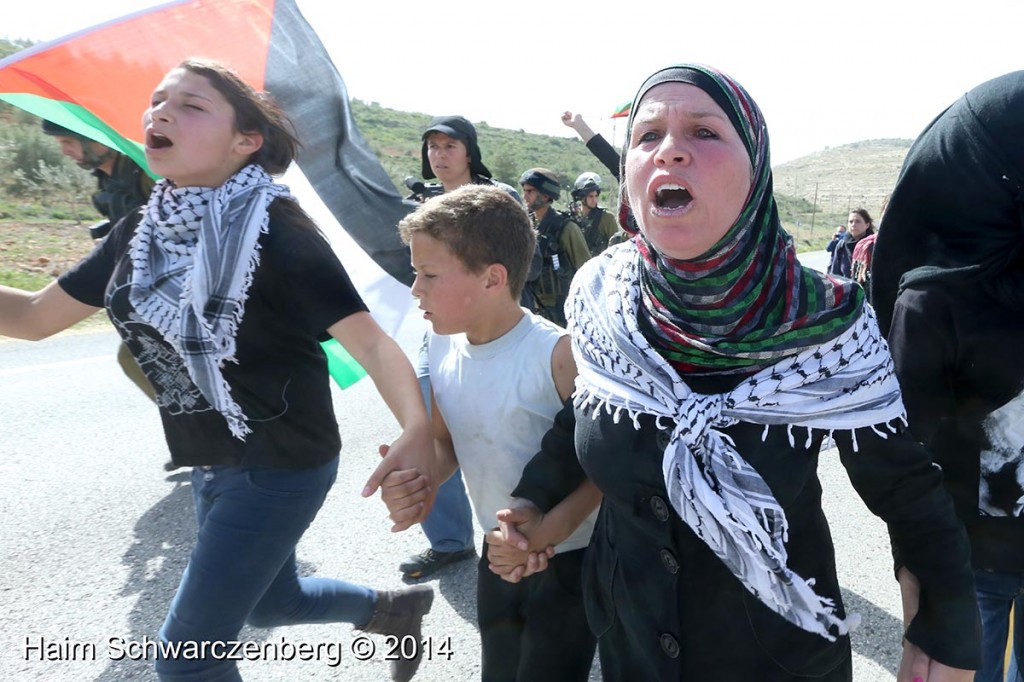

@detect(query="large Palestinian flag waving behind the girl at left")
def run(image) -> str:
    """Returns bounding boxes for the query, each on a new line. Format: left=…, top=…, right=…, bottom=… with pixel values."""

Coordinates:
left=0, top=0, right=414, bottom=383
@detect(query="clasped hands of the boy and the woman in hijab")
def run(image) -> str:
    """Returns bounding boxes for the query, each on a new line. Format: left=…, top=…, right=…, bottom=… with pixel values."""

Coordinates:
left=485, top=499, right=555, bottom=583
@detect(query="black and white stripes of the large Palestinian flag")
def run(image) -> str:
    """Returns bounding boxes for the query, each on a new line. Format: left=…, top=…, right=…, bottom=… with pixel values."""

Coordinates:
left=265, top=0, right=416, bottom=348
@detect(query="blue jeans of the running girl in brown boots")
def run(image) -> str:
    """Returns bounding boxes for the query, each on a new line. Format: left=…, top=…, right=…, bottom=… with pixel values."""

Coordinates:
left=156, top=457, right=377, bottom=682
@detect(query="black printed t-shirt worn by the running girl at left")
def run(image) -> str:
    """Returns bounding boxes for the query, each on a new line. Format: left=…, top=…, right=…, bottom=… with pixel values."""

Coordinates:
left=58, top=200, right=367, bottom=469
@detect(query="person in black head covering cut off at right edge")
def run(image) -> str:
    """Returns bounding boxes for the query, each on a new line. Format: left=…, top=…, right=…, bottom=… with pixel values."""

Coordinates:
left=872, top=71, right=1024, bottom=682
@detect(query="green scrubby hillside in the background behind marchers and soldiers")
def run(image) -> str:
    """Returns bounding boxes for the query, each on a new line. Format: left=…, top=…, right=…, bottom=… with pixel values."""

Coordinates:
left=0, top=40, right=910, bottom=251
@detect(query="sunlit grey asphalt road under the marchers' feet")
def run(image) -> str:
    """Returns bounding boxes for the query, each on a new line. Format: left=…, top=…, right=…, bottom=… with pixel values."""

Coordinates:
left=0, top=250, right=900, bottom=682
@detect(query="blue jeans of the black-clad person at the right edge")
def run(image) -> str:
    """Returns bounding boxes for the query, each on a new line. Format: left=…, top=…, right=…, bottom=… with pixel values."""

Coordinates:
left=974, top=570, right=1024, bottom=682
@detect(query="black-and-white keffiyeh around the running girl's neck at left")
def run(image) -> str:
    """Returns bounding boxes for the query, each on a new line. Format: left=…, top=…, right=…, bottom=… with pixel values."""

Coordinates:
left=129, top=164, right=290, bottom=440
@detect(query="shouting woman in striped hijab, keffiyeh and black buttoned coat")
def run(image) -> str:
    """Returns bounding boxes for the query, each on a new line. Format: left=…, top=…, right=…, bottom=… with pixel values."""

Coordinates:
left=485, top=66, right=980, bottom=682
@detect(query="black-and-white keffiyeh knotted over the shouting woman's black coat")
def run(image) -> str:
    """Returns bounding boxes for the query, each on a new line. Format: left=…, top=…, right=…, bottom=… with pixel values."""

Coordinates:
left=566, top=243, right=905, bottom=641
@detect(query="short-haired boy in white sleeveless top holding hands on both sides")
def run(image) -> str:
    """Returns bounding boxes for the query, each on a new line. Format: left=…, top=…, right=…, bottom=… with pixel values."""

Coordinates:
left=375, top=185, right=600, bottom=682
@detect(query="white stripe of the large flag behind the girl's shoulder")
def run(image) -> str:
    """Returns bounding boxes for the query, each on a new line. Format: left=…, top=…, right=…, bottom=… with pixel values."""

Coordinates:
left=281, top=164, right=416, bottom=336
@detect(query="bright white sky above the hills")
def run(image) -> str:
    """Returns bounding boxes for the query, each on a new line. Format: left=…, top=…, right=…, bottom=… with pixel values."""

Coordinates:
left=0, top=0, right=1024, bottom=164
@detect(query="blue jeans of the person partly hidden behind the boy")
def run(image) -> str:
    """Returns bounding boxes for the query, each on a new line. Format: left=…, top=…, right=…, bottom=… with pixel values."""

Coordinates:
left=416, top=337, right=473, bottom=552
